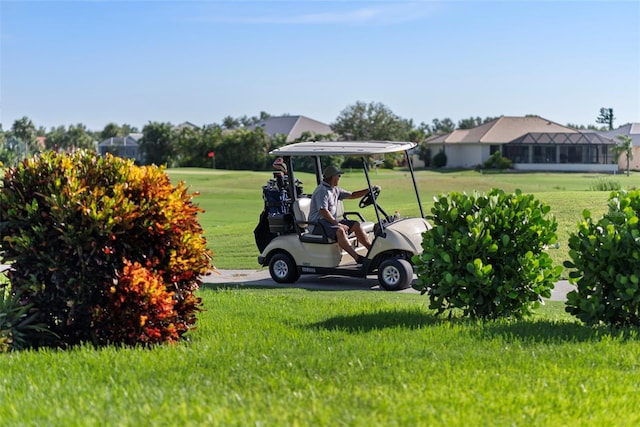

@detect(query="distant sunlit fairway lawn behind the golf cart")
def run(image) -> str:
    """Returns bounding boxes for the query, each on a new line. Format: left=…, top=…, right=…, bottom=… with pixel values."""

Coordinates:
left=168, top=169, right=640, bottom=269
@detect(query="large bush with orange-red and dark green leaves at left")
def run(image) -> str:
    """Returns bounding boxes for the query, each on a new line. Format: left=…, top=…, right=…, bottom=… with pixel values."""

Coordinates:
left=0, top=151, right=212, bottom=347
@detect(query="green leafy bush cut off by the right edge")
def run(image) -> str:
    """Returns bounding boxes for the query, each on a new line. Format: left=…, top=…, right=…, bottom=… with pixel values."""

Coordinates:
left=565, top=190, right=640, bottom=326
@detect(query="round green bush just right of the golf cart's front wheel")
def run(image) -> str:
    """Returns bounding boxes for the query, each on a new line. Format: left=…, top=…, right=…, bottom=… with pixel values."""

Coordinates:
left=413, top=189, right=562, bottom=318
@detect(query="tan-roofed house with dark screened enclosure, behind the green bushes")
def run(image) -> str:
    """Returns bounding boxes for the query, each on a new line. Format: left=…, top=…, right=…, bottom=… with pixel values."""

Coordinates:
left=425, top=116, right=618, bottom=172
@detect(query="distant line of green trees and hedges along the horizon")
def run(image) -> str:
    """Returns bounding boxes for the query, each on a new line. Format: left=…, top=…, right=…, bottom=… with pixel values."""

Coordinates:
left=0, top=101, right=614, bottom=170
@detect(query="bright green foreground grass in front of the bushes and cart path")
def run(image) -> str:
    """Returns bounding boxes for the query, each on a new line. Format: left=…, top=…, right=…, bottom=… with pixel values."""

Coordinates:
left=0, top=285, right=640, bottom=427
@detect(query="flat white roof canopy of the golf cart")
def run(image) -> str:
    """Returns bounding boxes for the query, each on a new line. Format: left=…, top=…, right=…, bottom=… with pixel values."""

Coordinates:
left=269, top=141, right=416, bottom=156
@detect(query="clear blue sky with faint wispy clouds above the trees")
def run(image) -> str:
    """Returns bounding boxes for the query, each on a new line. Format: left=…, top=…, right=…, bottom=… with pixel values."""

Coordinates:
left=0, top=0, right=640, bottom=130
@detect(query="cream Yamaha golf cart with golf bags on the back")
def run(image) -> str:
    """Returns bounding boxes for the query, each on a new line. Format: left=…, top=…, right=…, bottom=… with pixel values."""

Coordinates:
left=254, top=141, right=431, bottom=290
